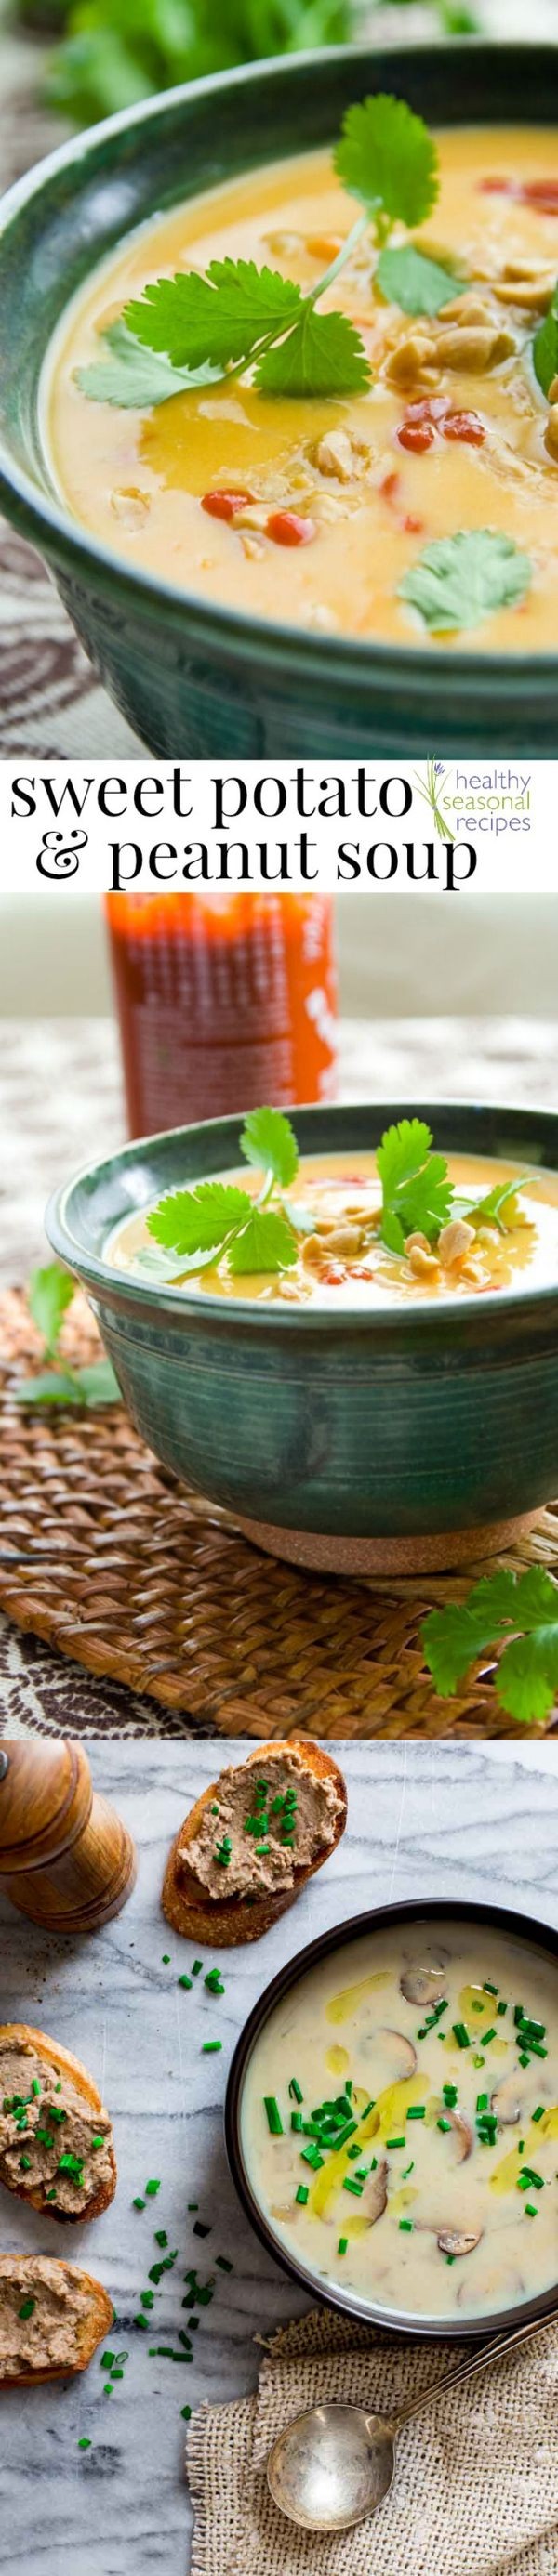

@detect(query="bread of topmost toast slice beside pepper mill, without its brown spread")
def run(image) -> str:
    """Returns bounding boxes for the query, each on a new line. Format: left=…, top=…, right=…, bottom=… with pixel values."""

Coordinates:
left=163, top=1736, right=346, bottom=1950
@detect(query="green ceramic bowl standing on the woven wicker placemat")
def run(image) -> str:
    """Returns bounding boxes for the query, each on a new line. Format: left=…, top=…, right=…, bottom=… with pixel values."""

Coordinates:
left=46, top=1102, right=558, bottom=1574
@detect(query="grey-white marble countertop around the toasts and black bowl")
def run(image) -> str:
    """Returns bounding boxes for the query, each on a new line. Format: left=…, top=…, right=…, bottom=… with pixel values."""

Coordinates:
left=0, top=1744, right=558, bottom=2576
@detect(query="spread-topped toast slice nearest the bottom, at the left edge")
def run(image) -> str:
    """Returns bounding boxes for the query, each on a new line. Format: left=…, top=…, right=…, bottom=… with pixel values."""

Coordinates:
left=0, top=2254, right=113, bottom=2390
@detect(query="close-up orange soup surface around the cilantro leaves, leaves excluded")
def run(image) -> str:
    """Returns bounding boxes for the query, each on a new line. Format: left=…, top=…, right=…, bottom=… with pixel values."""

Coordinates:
left=44, top=126, right=558, bottom=654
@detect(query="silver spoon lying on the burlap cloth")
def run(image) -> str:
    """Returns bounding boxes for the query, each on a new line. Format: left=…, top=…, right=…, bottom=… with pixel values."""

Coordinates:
left=266, top=2313, right=555, bottom=2532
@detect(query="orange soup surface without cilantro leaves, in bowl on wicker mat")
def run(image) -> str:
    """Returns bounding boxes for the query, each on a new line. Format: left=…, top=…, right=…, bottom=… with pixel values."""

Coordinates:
left=106, top=1154, right=558, bottom=1306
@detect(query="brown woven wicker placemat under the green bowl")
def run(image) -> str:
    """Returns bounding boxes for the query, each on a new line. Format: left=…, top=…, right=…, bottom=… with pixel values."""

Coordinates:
left=0, top=1291, right=558, bottom=1739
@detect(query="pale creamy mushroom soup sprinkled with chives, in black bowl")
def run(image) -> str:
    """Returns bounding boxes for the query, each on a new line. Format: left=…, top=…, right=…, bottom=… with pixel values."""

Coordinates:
left=240, top=1922, right=558, bottom=2319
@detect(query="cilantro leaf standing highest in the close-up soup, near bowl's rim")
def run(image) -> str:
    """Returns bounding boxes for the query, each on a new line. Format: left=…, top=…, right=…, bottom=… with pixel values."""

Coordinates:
left=333, top=90, right=439, bottom=231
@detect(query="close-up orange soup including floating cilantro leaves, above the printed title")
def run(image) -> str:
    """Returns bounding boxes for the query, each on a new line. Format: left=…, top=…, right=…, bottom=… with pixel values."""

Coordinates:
left=44, top=121, right=558, bottom=654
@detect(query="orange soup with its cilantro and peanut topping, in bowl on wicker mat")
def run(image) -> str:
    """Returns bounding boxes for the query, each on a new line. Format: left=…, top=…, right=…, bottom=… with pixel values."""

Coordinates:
left=106, top=1149, right=558, bottom=1308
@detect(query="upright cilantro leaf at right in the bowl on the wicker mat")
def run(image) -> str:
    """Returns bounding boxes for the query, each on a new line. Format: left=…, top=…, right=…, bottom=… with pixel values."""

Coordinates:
left=378, top=1118, right=452, bottom=1252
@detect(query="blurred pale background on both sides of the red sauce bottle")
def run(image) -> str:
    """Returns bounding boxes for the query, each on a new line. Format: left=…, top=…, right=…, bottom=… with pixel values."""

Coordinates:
left=0, top=884, right=558, bottom=1020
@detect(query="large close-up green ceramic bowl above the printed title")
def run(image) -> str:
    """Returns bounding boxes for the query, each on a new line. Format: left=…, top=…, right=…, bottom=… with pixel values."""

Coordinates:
left=0, top=39, right=558, bottom=768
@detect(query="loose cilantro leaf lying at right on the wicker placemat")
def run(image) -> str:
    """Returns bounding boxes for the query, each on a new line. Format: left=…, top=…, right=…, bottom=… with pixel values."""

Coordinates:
left=421, top=1566, right=558, bottom=1726
